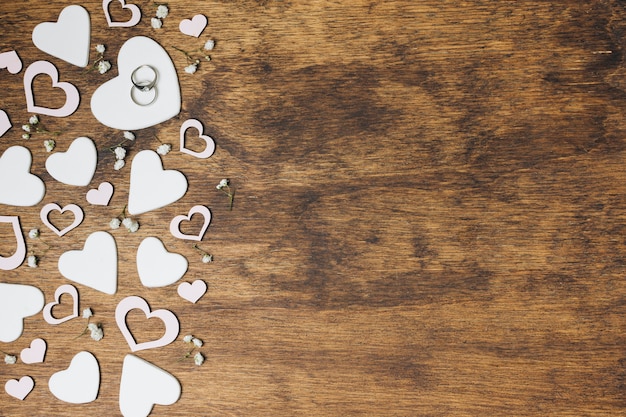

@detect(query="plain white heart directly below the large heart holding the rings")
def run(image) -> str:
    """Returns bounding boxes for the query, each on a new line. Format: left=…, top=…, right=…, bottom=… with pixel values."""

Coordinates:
left=128, top=150, right=187, bottom=214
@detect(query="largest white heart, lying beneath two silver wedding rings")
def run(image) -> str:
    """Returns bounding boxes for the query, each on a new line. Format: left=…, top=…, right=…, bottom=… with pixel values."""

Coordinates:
left=91, top=36, right=181, bottom=130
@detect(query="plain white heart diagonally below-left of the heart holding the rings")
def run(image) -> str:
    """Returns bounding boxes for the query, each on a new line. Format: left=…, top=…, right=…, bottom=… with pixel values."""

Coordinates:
left=46, top=136, right=98, bottom=186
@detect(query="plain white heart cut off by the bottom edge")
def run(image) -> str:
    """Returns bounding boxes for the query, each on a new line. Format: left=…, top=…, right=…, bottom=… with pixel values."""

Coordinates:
left=120, top=355, right=181, bottom=417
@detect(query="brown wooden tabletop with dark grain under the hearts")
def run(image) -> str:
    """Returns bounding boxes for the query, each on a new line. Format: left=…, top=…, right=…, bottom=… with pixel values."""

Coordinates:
left=0, top=0, right=626, bottom=416
